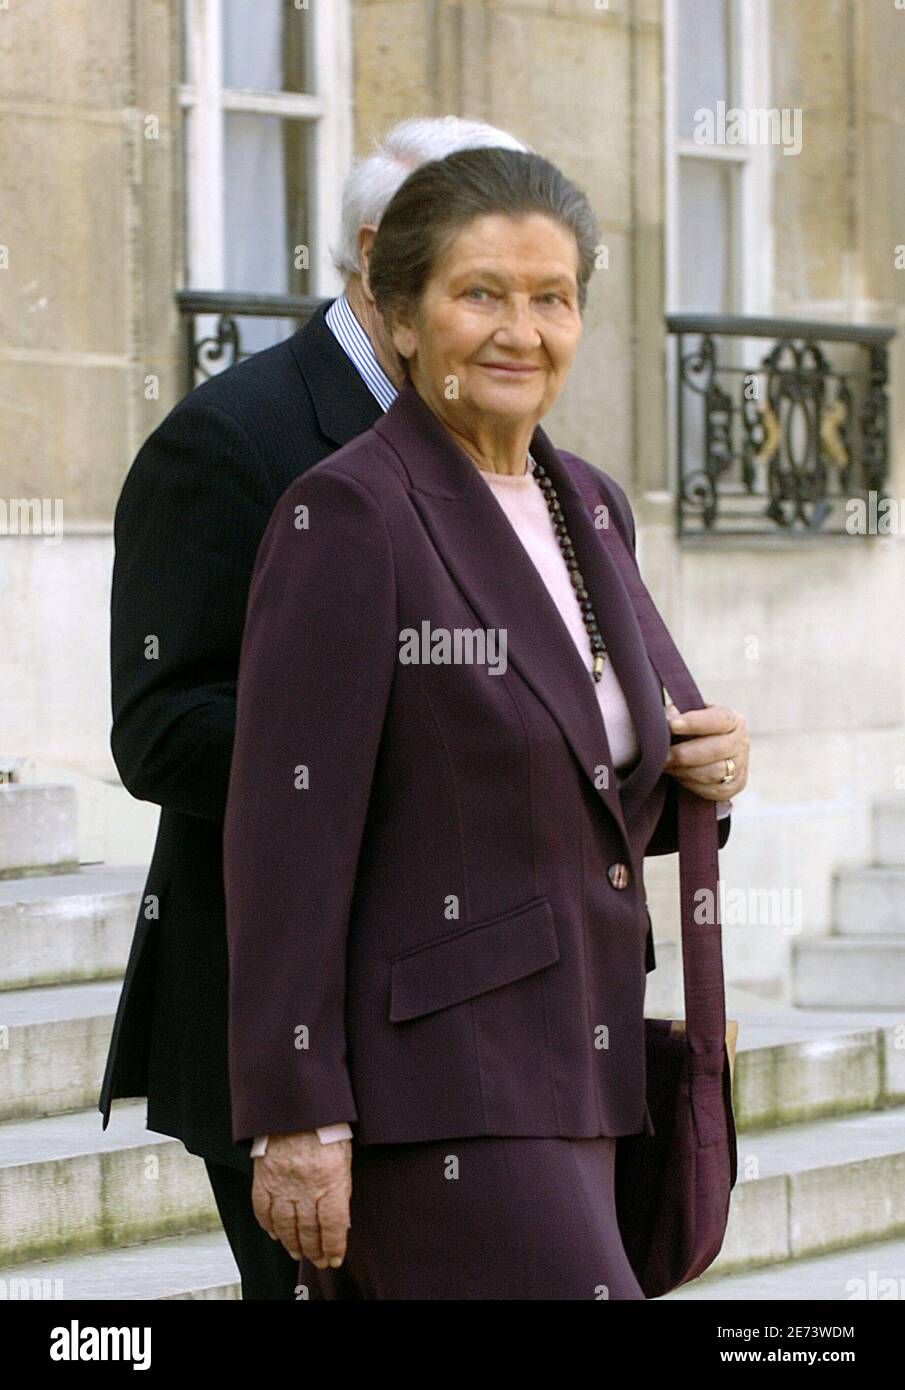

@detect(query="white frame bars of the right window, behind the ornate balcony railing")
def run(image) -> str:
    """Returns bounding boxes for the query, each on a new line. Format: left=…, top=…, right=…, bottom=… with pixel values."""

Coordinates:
left=663, top=0, right=773, bottom=492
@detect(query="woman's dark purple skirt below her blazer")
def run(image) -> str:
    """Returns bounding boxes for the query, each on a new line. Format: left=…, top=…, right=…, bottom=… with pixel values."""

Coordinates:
left=299, top=1136, right=644, bottom=1300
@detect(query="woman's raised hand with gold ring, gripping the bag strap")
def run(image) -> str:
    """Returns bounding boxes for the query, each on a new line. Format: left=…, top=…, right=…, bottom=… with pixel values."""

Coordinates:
left=663, top=703, right=748, bottom=801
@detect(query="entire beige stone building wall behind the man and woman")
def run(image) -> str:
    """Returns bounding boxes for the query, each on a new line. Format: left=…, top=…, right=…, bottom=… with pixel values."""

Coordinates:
left=0, top=0, right=905, bottom=991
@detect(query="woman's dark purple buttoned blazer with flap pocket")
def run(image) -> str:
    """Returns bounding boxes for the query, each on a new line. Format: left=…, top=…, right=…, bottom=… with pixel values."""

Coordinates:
left=224, top=386, right=728, bottom=1144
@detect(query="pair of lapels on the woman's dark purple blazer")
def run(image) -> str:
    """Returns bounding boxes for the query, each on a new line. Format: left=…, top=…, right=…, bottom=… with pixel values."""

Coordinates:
left=374, top=386, right=669, bottom=849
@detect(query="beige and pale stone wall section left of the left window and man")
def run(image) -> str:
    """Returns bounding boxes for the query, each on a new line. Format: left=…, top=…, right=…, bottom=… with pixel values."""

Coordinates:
left=0, top=0, right=182, bottom=777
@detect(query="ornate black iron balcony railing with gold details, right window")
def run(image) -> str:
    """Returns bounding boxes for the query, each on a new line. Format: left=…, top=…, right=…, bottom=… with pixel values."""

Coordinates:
left=666, top=314, right=895, bottom=537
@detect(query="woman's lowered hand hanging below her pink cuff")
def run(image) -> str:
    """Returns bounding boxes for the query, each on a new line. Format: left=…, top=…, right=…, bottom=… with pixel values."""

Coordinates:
left=252, top=1130, right=352, bottom=1269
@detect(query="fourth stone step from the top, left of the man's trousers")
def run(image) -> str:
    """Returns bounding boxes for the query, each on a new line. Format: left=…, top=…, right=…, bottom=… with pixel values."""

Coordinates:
left=0, top=1101, right=220, bottom=1266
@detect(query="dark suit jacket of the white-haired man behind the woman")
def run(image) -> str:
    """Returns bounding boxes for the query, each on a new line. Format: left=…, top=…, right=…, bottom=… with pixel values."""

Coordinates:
left=99, top=304, right=728, bottom=1170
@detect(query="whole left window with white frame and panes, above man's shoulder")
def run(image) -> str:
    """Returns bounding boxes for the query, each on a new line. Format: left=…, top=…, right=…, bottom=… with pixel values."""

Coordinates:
left=181, top=0, right=352, bottom=350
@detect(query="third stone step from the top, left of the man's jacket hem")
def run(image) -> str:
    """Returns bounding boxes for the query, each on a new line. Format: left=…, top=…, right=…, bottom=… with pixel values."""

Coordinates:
left=0, top=980, right=121, bottom=1120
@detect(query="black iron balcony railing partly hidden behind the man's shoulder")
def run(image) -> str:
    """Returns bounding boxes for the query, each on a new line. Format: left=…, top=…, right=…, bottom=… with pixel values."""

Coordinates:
left=177, top=289, right=323, bottom=391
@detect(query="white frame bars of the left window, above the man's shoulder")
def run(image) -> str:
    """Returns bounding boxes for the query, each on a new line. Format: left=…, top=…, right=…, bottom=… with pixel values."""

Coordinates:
left=179, top=0, right=352, bottom=297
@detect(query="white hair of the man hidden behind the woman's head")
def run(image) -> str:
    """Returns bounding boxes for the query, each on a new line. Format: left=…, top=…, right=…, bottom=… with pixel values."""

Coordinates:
left=331, top=115, right=531, bottom=279
